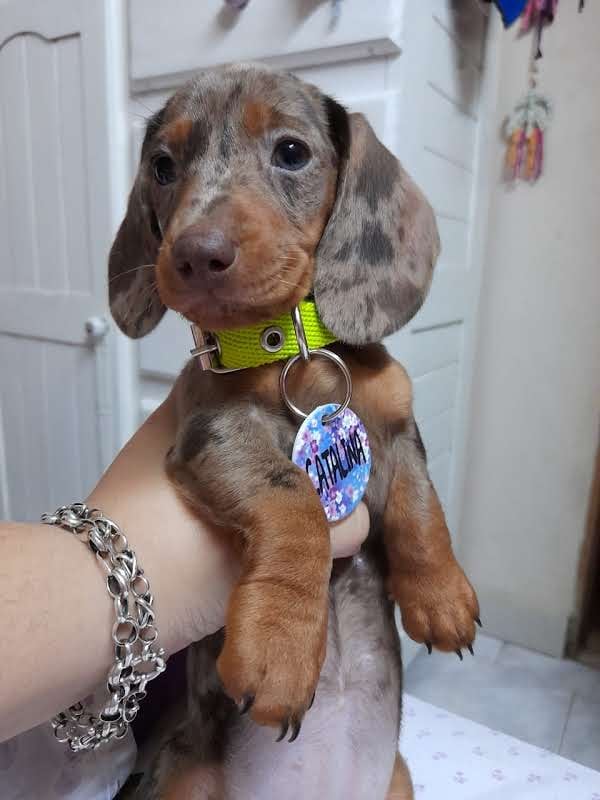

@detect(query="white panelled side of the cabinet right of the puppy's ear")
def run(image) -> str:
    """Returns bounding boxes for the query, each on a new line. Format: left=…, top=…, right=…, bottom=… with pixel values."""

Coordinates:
left=389, top=0, right=499, bottom=546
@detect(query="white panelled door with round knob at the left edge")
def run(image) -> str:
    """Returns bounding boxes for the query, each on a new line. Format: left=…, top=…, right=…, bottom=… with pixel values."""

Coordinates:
left=0, top=0, right=112, bottom=519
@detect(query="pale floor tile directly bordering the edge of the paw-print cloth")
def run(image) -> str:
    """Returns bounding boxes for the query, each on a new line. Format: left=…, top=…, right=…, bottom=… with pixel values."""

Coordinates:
left=404, top=656, right=572, bottom=752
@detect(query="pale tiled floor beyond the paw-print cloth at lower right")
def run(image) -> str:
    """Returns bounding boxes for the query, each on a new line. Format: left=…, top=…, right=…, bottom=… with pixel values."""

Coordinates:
left=404, top=636, right=600, bottom=770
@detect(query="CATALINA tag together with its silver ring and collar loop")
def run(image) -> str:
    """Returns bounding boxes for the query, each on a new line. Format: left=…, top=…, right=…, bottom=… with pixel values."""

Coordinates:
left=279, top=308, right=371, bottom=522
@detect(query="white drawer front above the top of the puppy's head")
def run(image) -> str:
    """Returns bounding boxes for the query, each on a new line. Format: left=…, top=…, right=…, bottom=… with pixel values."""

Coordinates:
left=129, top=0, right=402, bottom=86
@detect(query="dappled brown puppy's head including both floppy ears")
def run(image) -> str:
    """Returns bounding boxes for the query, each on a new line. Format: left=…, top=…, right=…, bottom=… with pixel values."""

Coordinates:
left=109, top=66, right=439, bottom=344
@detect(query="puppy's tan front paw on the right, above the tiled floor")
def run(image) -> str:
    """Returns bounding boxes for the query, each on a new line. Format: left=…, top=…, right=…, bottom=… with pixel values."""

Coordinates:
left=390, top=561, right=481, bottom=659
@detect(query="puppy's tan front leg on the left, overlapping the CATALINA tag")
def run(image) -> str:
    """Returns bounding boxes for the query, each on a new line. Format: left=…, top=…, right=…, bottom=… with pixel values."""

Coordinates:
left=167, top=407, right=331, bottom=740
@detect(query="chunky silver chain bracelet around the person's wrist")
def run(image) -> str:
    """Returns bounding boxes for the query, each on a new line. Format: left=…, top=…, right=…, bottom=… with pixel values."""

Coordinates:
left=42, top=503, right=166, bottom=752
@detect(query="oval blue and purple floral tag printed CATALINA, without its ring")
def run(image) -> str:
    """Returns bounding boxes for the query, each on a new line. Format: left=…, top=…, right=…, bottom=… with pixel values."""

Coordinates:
left=292, top=403, right=371, bottom=522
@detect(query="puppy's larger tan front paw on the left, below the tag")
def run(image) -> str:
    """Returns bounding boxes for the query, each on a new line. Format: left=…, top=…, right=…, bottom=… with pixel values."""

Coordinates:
left=217, top=582, right=327, bottom=742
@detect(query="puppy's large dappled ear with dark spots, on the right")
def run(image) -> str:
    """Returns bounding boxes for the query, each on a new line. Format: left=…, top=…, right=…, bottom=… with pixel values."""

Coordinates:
left=314, top=98, right=440, bottom=345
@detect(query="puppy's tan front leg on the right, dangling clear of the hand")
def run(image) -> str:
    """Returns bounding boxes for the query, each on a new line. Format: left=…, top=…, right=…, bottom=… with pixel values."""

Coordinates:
left=384, top=419, right=481, bottom=658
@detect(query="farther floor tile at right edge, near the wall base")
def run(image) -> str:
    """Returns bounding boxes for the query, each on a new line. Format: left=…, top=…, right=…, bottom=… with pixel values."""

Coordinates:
left=495, top=644, right=600, bottom=700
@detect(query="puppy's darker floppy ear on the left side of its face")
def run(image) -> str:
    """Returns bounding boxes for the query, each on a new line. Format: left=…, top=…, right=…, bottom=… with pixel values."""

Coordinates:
left=108, top=112, right=166, bottom=339
